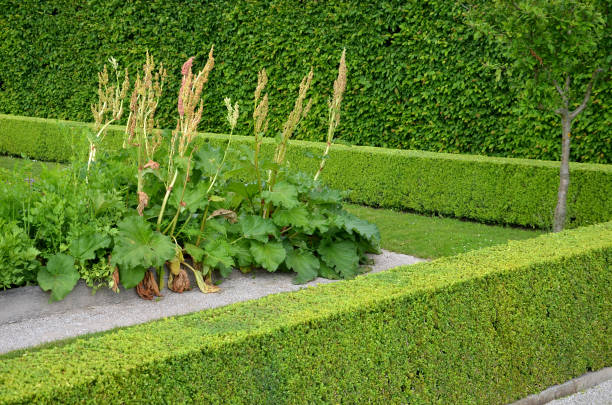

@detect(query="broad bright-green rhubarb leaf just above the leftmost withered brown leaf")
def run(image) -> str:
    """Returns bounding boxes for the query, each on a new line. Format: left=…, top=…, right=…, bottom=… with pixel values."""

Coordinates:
left=113, top=216, right=175, bottom=269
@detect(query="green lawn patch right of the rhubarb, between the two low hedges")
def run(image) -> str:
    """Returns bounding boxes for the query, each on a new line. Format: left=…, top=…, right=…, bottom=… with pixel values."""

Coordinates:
left=344, top=204, right=544, bottom=259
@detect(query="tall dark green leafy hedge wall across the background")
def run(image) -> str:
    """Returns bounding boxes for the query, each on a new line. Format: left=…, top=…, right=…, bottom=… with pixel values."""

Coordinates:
left=0, top=0, right=612, bottom=163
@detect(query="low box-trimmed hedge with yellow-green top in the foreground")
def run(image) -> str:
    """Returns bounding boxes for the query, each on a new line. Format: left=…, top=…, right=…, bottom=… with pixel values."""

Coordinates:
left=0, top=222, right=612, bottom=404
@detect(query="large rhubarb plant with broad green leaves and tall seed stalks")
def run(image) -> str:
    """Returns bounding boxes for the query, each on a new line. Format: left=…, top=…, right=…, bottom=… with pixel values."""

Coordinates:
left=10, top=48, right=380, bottom=299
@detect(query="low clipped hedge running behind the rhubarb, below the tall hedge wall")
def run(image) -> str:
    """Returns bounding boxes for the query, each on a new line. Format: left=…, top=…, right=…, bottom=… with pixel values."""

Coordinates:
left=0, top=115, right=612, bottom=229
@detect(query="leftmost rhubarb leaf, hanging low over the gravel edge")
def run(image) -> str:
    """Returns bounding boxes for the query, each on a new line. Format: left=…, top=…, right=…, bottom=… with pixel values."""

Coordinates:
left=37, top=253, right=79, bottom=301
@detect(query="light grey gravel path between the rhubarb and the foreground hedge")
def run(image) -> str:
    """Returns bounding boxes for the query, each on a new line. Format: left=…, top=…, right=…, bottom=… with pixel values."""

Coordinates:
left=0, top=250, right=423, bottom=353
